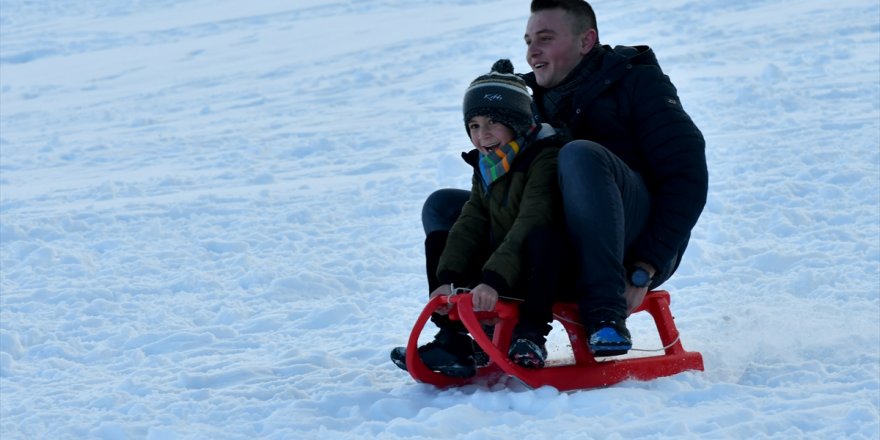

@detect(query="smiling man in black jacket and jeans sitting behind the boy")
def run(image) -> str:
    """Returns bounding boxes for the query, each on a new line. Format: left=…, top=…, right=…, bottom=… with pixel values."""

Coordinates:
left=422, top=0, right=708, bottom=356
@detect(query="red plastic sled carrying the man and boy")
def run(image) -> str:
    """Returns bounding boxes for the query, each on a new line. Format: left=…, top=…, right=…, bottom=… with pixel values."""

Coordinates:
left=406, top=290, right=703, bottom=391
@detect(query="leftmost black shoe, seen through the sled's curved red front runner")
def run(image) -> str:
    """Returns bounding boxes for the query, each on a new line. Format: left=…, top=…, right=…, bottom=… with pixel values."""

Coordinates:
left=391, top=330, right=477, bottom=378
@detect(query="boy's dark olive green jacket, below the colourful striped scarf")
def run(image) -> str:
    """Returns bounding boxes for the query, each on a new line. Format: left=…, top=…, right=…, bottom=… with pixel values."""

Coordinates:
left=437, top=127, right=569, bottom=295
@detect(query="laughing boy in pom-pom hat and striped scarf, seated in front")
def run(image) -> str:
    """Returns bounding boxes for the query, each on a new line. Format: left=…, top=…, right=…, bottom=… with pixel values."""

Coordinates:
left=391, top=60, right=570, bottom=377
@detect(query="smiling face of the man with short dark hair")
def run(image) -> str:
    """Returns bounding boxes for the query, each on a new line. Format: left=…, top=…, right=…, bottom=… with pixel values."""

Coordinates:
left=524, top=9, right=596, bottom=88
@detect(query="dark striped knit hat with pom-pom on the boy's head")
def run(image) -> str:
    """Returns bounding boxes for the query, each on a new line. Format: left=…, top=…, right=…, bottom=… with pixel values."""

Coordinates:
left=463, top=59, right=535, bottom=134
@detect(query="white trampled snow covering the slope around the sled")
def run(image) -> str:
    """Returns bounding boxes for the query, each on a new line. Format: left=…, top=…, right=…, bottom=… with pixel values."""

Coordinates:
left=0, top=0, right=880, bottom=440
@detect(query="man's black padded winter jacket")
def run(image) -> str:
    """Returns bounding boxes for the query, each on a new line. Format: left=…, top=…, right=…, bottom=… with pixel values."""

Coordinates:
left=523, top=45, right=709, bottom=279
